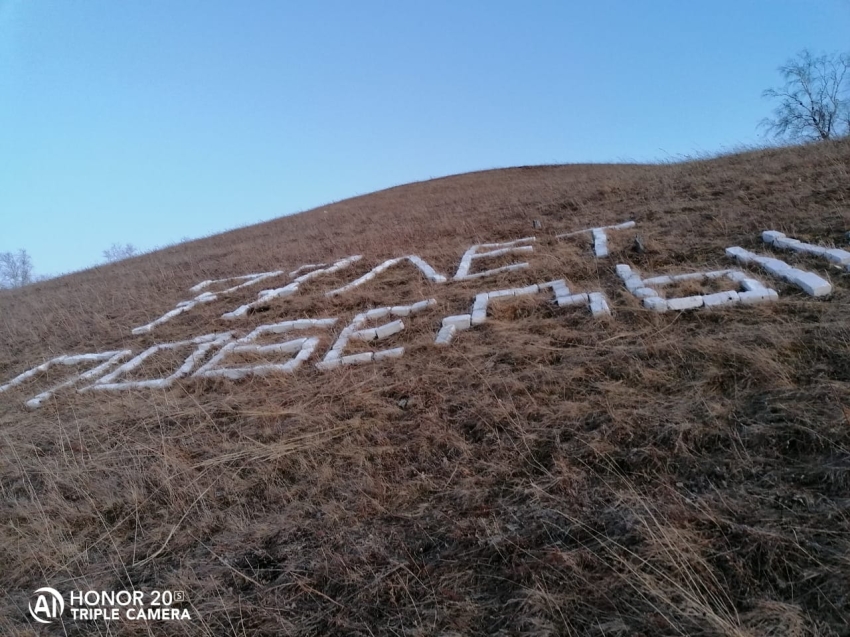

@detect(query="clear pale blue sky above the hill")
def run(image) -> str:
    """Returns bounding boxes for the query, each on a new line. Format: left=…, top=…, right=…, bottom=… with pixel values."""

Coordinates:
left=0, top=0, right=850, bottom=274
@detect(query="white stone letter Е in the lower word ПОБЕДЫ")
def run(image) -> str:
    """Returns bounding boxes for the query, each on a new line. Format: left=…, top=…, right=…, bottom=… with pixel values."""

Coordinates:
left=316, top=299, right=437, bottom=370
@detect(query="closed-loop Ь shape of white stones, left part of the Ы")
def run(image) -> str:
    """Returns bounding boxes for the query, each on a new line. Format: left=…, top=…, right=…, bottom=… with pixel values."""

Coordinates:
left=615, top=263, right=779, bottom=312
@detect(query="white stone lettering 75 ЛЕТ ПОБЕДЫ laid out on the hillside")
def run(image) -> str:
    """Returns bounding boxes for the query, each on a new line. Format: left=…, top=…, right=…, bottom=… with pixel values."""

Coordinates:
left=6, top=229, right=850, bottom=408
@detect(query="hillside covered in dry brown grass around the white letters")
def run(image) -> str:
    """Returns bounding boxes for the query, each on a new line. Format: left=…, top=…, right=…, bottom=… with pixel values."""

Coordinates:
left=0, top=141, right=850, bottom=636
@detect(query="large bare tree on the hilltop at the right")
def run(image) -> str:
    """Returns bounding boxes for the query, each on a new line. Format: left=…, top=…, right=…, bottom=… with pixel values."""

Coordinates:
left=762, top=51, right=850, bottom=141
